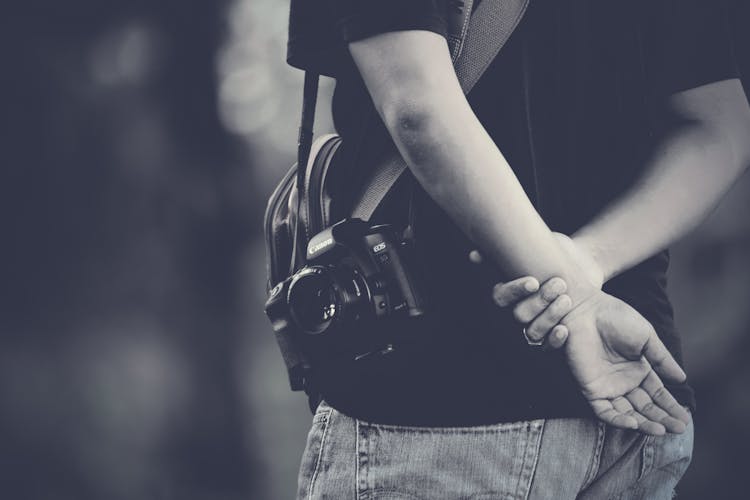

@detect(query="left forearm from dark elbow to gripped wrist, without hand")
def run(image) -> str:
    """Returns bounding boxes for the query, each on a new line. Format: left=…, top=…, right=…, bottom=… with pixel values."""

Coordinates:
left=383, top=91, right=592, bottom=303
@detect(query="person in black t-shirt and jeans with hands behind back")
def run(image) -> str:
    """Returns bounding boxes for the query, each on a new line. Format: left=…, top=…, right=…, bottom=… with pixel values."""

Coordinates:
left=290, top=0, right=750, bottom=499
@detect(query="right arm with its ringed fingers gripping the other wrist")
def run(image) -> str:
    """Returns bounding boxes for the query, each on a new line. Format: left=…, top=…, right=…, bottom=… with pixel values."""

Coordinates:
left=494, top=79, right=750, bottom=356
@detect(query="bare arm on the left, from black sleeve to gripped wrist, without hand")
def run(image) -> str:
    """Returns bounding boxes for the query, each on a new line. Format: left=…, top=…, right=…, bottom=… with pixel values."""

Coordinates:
left=350, top=31, right=594, bottom=302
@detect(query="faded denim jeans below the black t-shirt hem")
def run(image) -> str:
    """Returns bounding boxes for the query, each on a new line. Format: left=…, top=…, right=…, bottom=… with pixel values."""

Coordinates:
left=297, top=402, right=693, bottom=500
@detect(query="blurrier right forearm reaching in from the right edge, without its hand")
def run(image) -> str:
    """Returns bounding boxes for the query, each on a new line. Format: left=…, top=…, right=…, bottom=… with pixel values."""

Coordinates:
left=573, top=83, right=750, bottom=281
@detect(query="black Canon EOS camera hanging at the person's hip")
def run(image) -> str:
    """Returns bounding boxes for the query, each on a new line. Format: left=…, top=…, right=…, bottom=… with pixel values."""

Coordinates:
left=265, top=219, right=425, bottom=360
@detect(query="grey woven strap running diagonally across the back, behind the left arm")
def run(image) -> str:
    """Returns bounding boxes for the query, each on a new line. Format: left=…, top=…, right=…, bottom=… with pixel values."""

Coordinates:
left=351, top=0, right=529, bottom=220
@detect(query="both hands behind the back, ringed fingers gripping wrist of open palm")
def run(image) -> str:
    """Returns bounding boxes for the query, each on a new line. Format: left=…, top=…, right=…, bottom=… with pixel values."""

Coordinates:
left=475, top=235, right=690, bottom=435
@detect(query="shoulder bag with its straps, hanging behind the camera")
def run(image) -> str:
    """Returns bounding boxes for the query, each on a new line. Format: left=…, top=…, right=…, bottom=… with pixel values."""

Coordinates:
left=264, top=0, right=529, bottom=402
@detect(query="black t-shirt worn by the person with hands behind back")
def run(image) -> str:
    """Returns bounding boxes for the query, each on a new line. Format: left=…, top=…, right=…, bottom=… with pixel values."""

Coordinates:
left=289, top=0, right=736, bottom=426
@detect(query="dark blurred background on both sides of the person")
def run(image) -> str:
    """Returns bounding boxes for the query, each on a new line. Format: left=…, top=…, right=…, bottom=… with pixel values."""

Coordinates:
left=0, top=0, right=750, bottom=500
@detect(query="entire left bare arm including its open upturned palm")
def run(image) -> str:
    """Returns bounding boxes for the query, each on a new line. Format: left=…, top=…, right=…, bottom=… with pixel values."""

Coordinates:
left=349, top=31, right=689, bottom=434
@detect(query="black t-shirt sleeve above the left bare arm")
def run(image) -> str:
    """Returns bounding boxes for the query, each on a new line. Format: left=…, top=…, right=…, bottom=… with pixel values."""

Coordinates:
left=327, top=0, right=448, bottom=42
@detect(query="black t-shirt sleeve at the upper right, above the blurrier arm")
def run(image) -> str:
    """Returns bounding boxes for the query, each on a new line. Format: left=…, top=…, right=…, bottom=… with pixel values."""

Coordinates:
left=649, top=0, right=738, bottom=96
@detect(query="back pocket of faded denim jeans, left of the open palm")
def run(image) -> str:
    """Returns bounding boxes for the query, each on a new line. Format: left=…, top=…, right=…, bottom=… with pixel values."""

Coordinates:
left=357, top=421, right=544, bottom=500
